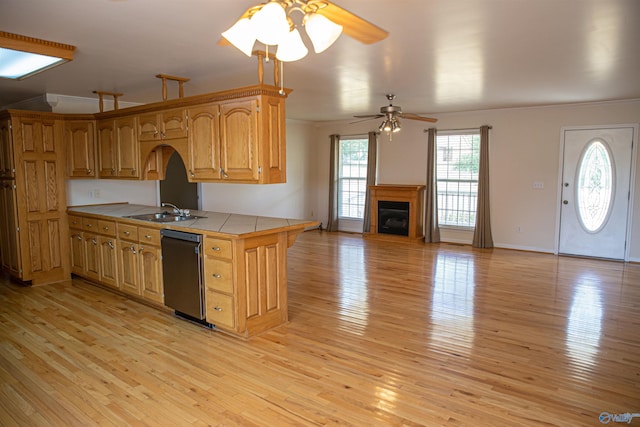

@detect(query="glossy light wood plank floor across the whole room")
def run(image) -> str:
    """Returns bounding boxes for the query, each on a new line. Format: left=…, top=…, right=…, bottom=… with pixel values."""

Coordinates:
left=0, top=231, right=640, bottom=426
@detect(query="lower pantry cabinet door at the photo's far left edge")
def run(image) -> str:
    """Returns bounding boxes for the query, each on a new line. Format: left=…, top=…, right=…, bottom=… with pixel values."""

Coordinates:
left=0, top=181, right=21, bottom=277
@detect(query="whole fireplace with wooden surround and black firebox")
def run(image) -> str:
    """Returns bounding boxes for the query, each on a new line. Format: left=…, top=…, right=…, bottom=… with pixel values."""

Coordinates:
left=366, top=184, right=424, bottom=240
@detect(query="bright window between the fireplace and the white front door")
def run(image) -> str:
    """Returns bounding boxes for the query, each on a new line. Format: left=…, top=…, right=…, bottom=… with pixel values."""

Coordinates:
left=436, top=131, right=480, bottom=228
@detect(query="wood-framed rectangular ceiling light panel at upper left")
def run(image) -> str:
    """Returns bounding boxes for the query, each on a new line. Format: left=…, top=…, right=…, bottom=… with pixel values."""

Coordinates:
left=0, top=31, right=75, bottom=80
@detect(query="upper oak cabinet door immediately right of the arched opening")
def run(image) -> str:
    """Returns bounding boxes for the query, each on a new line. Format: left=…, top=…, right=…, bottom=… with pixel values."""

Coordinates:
left=187, top=105, right=220, bottom=180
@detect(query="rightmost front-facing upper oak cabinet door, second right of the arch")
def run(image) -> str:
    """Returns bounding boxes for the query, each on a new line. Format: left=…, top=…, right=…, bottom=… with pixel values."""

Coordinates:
left=220, top=99, right=259, bottom=182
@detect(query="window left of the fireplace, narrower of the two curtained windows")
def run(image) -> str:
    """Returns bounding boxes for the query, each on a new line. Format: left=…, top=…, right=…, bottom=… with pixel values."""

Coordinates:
left=338, top=137, right=369, bottom=220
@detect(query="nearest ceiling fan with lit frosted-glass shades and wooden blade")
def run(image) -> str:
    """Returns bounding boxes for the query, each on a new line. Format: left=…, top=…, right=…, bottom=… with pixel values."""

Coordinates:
left=218, top=0, right=389, bottom=61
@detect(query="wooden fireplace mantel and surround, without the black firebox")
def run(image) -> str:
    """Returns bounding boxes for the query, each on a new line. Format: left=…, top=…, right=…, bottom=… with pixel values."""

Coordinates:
left=367, top=184, right=425, bottom=240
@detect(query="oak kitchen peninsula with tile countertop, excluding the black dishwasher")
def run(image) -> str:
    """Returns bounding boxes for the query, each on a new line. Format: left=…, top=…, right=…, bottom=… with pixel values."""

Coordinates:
left=67, top=203, right=318, bottom=338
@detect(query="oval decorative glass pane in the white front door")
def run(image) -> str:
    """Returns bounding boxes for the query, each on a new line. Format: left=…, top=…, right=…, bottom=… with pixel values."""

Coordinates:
left=576, top=140, right=614, bottom=233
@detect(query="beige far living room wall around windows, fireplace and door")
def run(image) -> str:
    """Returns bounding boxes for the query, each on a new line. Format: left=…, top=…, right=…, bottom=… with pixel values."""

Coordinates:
left=314, top=100, right=640, bottom=261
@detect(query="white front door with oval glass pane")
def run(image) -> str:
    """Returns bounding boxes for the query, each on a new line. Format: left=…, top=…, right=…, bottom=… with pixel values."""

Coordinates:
left=558, top=127, right=635, bottom=259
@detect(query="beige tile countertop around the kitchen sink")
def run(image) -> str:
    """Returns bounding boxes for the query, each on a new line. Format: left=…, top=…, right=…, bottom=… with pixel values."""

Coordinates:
left=67, top=203, right=318, bottom=237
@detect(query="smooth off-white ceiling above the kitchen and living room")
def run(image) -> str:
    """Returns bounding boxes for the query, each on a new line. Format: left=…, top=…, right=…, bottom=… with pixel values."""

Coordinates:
left=0, top=0, right=640, bottom=121
